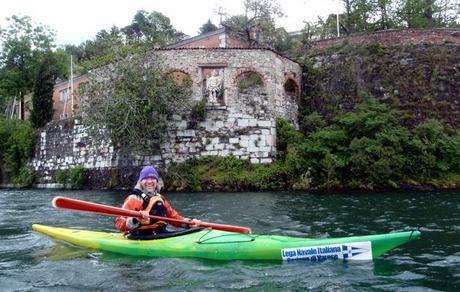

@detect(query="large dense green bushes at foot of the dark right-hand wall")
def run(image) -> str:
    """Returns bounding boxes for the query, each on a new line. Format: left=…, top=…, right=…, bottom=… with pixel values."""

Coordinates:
left=284, top=99, right=460, bottom=189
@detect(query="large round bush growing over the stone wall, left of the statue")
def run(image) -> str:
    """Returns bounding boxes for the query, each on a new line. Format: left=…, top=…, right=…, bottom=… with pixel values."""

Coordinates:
left=82, top=56, right=191, bottom=153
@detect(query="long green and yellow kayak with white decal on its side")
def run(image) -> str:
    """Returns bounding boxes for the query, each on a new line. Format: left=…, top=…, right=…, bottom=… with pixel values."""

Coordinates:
left=32, top=224, right=420, bottom=262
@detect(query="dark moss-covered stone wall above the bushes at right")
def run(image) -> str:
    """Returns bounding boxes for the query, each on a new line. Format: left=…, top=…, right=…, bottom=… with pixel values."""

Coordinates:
left=297, top=44, right=460, bottom=127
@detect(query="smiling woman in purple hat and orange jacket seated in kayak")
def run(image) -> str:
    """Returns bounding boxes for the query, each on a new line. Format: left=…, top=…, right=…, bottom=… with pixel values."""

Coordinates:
left=116, top=165, right=201, bottom=235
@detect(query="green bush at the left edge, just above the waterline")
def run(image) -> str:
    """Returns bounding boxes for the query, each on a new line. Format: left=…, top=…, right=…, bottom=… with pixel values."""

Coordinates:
left=0, top=117, right=34, bottom=183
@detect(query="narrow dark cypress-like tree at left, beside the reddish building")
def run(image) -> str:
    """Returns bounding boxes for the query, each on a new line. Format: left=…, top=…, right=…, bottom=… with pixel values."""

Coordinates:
left=30, top=52, right=58, bottom=128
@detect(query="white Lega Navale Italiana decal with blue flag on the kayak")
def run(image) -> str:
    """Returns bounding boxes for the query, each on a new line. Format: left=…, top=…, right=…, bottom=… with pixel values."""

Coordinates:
left=281, top=241, right=372, bottom=262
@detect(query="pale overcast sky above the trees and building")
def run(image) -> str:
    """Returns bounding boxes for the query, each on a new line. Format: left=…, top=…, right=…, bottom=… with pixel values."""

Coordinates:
left=0, top=0, right=338, bottom=45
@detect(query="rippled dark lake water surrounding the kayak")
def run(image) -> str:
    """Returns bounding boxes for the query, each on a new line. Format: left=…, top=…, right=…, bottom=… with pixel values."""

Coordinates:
left=0, top=190, right=460, bottom=291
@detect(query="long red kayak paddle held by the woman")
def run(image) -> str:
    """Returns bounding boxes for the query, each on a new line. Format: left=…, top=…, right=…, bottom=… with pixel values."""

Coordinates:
left=52, top=196, right=251, bottom=234
